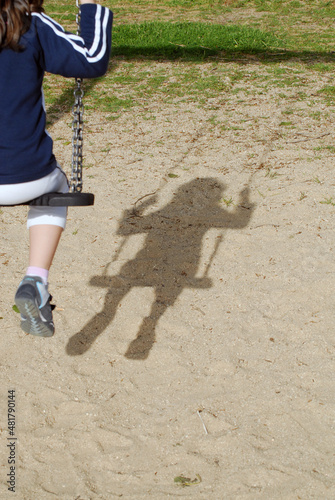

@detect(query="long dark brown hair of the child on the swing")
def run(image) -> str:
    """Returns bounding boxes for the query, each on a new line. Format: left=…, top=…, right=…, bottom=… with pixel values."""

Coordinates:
left=0, top=0, right=43, bottom=51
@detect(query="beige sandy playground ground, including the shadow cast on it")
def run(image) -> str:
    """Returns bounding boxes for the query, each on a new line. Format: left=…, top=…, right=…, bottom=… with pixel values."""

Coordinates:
left=0, top=61, right=335, bottom=500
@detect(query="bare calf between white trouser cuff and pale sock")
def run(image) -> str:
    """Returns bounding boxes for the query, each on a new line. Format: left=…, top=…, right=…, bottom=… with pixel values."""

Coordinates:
left=29, top=224, right=63, bottom=270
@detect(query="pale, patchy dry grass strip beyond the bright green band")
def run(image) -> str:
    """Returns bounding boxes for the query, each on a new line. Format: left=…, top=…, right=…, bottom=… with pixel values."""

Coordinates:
left=46, top=0, right=335, bottom=52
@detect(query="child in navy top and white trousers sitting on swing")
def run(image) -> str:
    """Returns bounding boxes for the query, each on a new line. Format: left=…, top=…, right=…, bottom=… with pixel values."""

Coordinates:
left=0, top=0, right=113, bottom=337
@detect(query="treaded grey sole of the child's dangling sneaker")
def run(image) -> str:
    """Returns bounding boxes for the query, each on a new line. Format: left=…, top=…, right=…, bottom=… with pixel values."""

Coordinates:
left=15, top=297, right=55, bottom=337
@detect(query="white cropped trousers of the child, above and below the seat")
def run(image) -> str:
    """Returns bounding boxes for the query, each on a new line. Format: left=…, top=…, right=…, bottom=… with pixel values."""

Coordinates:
left=0, top=168, right=69, bottom=229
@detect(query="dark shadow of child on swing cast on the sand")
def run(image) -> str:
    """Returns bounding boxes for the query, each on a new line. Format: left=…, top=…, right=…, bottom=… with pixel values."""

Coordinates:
left=66, top=178, right=253, bottom=360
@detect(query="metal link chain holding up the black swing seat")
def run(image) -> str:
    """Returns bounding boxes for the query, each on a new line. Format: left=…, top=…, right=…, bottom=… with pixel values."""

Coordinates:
left=70, top=0, right=84, bottom=193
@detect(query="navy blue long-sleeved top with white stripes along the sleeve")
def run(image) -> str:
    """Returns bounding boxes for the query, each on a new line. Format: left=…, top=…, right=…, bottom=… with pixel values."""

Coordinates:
left=0, top=4, right=113, bottom=184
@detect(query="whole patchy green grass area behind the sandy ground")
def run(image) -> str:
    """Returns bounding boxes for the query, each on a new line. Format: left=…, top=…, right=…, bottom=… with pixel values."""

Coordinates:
left=45, top=0, right=335, bottom=114
